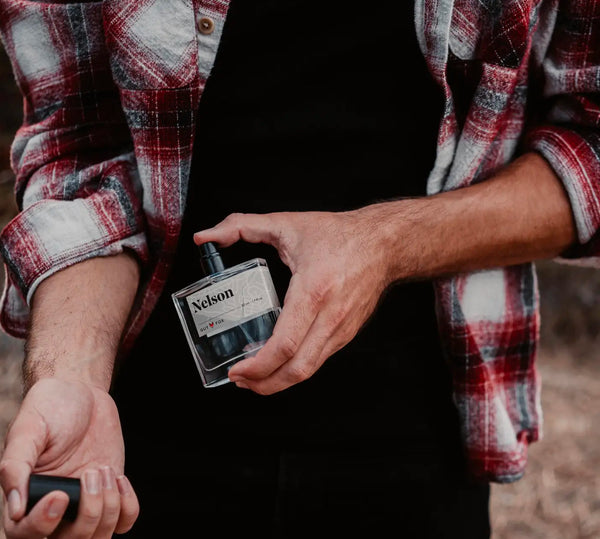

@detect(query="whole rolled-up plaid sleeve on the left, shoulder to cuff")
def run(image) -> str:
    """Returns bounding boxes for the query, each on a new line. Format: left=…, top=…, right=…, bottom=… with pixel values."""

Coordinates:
left=0, top=0, right=148, bottom=337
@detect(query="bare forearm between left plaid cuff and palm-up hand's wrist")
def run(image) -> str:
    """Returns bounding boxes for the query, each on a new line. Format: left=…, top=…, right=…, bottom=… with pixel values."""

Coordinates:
left=23, top=254, right=139, bottom=390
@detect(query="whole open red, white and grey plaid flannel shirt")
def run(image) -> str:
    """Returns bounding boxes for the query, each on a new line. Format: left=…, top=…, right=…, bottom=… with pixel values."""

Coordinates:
left=0, top=0, right=600, bottom=482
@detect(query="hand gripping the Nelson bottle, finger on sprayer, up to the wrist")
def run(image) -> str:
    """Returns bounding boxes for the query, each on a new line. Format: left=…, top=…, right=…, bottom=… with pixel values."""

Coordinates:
left=194, top=207, right=396, bottom=395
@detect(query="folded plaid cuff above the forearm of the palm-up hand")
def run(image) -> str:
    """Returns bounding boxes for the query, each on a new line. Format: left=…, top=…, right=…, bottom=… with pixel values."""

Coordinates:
left=0, top=191, right=148, bottom=338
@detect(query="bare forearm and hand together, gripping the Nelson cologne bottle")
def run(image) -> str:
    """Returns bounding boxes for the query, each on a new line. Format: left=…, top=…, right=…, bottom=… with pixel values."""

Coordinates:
left=194, top=150, right=575, bottom=394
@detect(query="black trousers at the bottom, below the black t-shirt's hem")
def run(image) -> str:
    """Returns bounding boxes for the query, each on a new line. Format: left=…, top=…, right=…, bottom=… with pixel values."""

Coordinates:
left=123, top=445, right=490, bottom=539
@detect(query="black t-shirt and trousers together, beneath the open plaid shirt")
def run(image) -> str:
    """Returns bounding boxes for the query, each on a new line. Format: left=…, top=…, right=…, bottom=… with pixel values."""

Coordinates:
left=113, top=0, right=489, bottom=539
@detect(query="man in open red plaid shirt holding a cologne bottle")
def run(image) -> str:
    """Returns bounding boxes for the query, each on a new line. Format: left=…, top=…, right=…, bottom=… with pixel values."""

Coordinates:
left=0, top=0, right=600, bottom=537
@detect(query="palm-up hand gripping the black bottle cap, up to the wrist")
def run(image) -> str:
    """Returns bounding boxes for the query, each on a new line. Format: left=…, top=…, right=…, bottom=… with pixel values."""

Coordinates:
left=0, top=378, right=139, bottom=539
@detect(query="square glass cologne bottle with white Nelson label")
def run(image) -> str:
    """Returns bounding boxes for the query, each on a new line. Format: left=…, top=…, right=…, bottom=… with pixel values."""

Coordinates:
left=172, top=242, right=281, bottom=387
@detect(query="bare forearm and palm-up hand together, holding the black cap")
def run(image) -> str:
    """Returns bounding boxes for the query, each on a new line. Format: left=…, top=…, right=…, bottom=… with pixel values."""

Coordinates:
left=0, top=253, right=139, bottom=539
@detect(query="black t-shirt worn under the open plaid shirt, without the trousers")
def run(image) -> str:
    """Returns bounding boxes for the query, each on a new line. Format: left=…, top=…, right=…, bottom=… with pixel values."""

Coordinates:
left=115, top=0, right=458, bottom=456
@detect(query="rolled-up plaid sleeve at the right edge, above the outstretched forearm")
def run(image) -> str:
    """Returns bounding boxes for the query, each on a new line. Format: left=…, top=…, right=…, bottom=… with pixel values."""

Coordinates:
left=525, top=2, right=600, bottom=266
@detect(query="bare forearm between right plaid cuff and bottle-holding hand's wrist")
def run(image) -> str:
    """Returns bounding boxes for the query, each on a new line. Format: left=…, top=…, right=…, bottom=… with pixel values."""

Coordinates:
left=377, top=153, right=576, bottom=281
